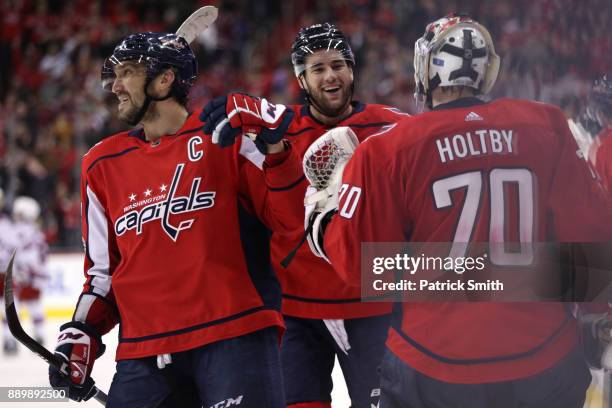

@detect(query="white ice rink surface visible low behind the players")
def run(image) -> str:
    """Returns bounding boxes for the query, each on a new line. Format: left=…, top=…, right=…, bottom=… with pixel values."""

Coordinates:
left=0, top=319, right=350, bottom=408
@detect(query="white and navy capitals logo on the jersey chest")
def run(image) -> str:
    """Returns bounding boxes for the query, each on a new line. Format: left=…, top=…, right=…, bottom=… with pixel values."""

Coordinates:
left=115, top=163, right=216, bottom=242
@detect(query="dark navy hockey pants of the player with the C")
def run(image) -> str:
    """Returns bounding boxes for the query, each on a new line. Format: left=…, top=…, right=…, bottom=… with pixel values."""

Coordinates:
left=106, top=328, right=285, bottom=408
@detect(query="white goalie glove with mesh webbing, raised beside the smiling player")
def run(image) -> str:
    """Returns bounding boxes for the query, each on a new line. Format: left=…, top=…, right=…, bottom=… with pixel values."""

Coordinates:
left=302, top=126, right=359, bottom=262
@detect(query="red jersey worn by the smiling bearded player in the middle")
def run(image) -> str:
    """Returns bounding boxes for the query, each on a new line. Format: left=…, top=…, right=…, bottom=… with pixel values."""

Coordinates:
left=272, top=102, right=409, bottom=319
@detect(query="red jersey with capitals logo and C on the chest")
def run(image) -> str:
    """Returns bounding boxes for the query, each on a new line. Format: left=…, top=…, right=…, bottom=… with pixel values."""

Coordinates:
left=73, top=114, right=303, bottom=360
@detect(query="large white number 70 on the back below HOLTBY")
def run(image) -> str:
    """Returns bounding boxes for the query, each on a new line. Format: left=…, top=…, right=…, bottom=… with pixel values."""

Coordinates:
left=432, top=169, right=534, bottom=266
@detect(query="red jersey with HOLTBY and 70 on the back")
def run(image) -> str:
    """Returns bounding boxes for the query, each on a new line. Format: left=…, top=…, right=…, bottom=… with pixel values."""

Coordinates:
left=324, top=98, right=612, bottom=383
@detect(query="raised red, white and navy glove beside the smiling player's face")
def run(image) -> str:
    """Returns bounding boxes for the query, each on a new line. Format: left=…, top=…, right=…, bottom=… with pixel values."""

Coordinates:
left=200, top=93, right=294, bottom=154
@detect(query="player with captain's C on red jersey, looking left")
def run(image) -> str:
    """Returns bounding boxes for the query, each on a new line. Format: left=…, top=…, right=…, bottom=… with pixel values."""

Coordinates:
left=50, top=33, right=303, bottom=408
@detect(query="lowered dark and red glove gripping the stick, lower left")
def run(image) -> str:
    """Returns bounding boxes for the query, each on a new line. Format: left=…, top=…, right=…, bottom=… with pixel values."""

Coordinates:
left=49, top=321, right=106, bottom=401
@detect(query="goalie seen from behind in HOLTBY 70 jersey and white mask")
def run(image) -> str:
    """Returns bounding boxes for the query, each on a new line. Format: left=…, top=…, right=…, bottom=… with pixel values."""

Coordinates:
left=309, top=15, right=612, bottom=408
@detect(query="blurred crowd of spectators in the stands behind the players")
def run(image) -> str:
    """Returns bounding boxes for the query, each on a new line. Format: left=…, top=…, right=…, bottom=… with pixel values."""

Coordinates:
left=0, top=0, right=612, bottom=249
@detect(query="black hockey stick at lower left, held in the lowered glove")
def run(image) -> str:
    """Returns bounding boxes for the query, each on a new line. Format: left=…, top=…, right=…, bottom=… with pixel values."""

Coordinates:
left=4, top=251, right=107, bottom=405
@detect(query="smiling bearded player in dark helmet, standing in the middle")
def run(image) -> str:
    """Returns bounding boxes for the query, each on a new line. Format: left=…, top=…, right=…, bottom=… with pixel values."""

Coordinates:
left=203, top=23, right=408, bottom=408
